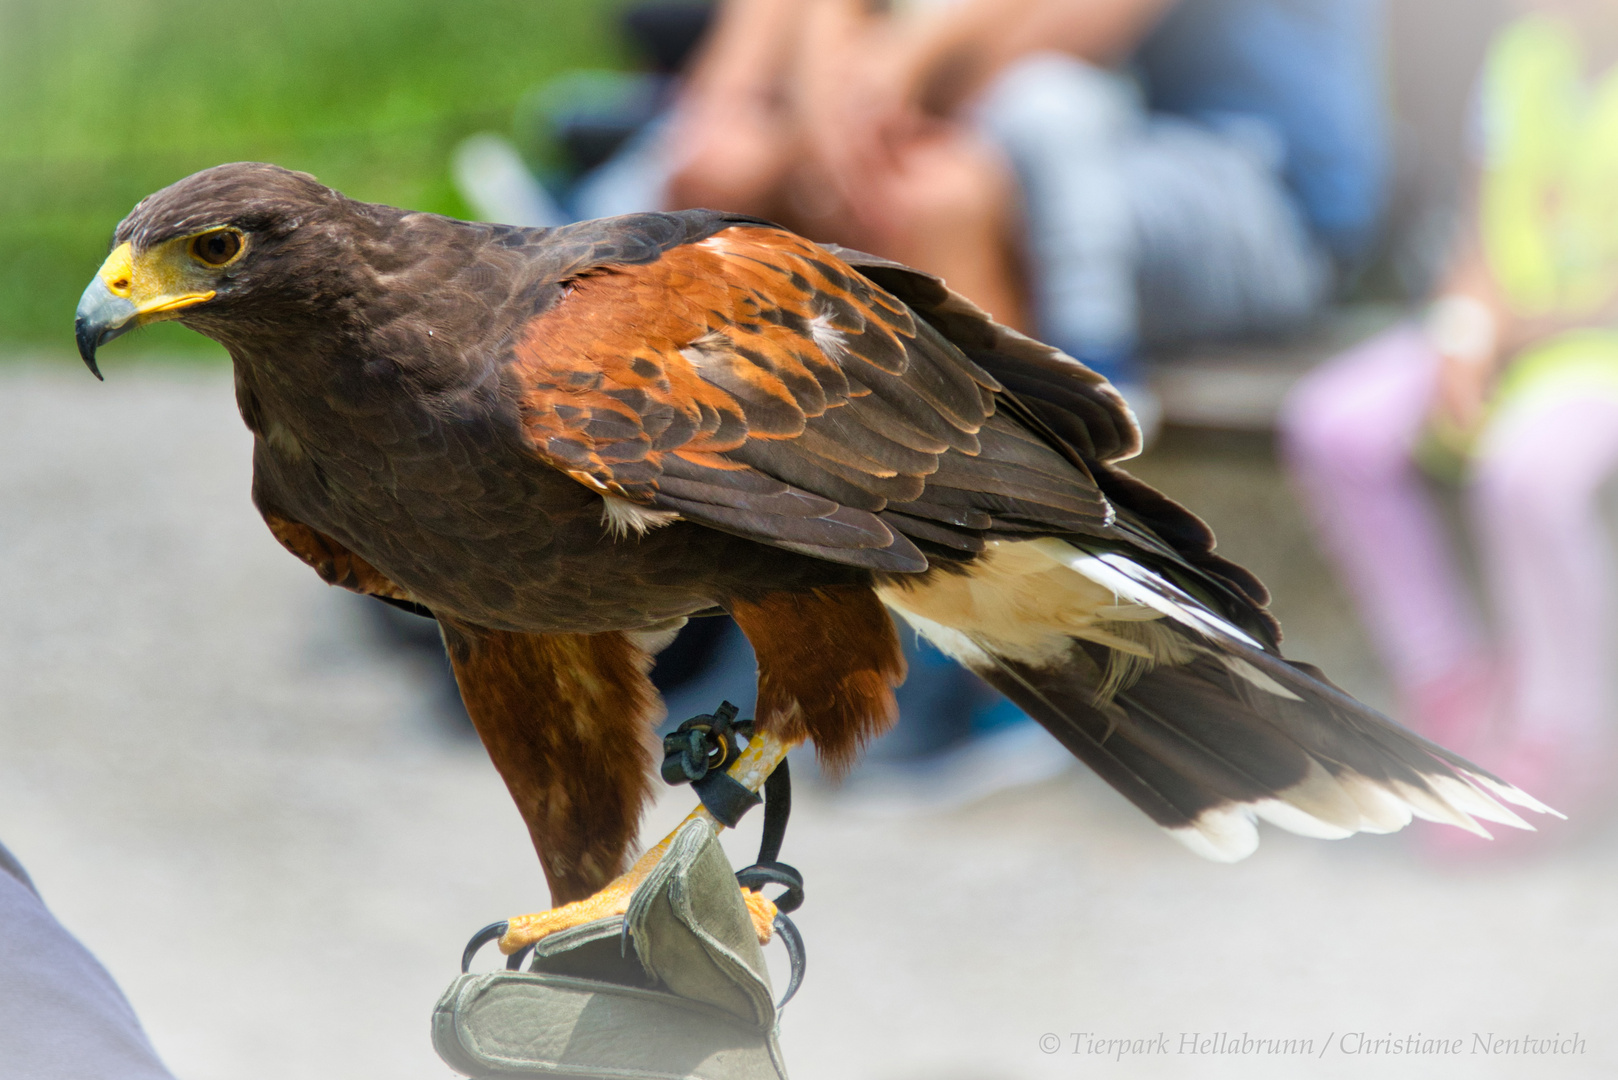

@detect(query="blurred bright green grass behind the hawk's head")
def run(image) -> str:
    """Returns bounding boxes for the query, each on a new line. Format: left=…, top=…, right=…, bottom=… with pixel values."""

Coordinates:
left=0, top=0, right=620, bottom=348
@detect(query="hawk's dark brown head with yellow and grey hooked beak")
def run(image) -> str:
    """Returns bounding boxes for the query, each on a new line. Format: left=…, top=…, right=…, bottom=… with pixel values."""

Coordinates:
left=74, top=162, right=357, bottom=379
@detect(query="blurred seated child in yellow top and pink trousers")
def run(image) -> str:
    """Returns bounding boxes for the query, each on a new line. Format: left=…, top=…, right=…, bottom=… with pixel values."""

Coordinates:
left=1281, top=0, right=1618, bottom=845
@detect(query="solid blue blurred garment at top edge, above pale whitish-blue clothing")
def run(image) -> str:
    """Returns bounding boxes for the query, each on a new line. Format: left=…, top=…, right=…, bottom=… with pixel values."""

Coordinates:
left=1134, top=0, right=1388, bottom=259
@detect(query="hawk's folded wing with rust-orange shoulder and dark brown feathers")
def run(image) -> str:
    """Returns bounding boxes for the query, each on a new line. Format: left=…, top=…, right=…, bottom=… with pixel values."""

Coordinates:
left=513, top=222, right=1134, bottom=572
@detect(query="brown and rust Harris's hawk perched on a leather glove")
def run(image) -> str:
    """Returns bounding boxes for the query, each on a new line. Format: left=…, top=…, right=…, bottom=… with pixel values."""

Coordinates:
left=76, top=164, right=1545, bottom=950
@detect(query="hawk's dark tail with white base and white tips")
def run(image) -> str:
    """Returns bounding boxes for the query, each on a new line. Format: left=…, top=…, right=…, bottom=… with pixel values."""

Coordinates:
left=883, top=539, right=1555, bottom=861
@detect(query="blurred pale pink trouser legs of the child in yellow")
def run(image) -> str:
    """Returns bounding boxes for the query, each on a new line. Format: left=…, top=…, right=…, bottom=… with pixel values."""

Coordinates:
left=1281, top=327, right=1618, bottom=742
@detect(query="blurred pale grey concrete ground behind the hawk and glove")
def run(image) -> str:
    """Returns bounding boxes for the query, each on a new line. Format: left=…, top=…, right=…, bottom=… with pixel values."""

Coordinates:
left=0, top=362, right=1618, bottom=1080
